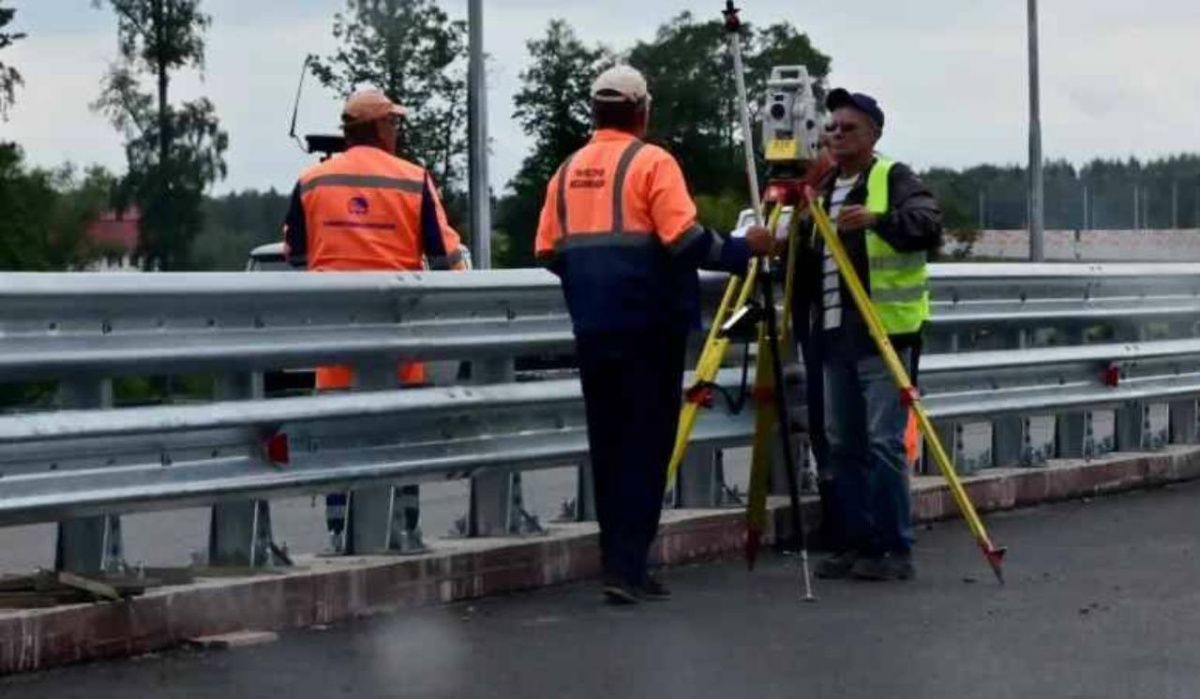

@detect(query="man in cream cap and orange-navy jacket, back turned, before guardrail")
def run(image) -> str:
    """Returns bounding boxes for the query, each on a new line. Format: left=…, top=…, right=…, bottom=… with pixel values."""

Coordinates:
left=536, top=66, right=774, bottom=603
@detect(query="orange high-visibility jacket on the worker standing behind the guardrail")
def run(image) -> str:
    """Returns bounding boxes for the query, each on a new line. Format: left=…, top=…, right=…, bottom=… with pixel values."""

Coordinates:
left=284, top=145, right=463, bottom=389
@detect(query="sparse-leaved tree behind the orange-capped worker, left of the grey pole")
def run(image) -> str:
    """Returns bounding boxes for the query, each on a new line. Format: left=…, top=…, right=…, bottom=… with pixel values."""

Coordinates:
left=313, top=0, right=467, bottom=190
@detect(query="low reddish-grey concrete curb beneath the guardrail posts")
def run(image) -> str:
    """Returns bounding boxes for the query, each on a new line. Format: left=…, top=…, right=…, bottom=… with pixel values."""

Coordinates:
left=0, top=447, right=1200, bottom=674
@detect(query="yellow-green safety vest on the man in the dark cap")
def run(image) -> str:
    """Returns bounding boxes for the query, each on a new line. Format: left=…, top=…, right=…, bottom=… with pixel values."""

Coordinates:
left=866, top=159, right=929, bottom=335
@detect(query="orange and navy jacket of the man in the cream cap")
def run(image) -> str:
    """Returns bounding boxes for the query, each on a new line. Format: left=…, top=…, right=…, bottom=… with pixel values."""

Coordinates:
left=536, top=130, right=750, bottom=333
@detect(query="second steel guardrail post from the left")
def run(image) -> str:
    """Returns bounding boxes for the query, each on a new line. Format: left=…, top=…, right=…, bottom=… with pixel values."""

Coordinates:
left=209, top=372, right=289, bottom=568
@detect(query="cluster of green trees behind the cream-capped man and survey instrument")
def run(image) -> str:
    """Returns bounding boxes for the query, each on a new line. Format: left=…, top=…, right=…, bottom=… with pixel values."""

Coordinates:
left=497, top=17, right=829, bottom=267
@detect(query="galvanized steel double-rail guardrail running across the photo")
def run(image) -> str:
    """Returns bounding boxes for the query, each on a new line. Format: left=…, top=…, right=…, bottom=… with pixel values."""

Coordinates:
left=0, top=264, right=1200, bottom=569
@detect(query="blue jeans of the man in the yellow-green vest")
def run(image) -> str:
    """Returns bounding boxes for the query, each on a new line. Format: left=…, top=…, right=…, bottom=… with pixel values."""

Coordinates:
left=826, top=350, right=913, bottom=555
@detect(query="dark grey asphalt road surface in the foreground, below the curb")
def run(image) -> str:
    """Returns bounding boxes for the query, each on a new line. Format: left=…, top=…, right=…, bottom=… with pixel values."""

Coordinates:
left=0, top=485, right=1200, bottom=699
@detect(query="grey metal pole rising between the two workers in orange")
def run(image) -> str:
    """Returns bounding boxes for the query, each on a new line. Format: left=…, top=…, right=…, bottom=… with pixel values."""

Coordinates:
left=467, top=0, right=492, bottom=269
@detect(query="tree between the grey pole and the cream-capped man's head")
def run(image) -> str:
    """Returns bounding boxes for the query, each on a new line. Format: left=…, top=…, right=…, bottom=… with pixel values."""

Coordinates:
left=497, top=19, right=612, bottom=267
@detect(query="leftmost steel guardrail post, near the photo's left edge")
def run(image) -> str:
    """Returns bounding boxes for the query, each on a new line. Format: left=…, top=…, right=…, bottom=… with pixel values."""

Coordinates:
left=54, top=378, right=125, bottom=573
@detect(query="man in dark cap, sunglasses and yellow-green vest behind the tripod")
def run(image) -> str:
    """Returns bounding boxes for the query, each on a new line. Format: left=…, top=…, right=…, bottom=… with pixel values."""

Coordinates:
left=796, top=89, right=942, bottom=580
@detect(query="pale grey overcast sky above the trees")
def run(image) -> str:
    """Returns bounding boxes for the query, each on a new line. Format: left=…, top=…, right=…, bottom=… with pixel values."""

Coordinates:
left=0, top=0, right=1200, bottom=192
